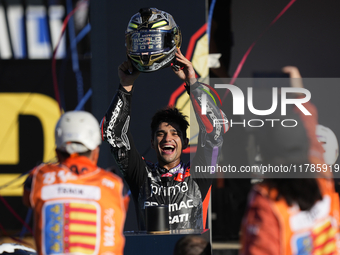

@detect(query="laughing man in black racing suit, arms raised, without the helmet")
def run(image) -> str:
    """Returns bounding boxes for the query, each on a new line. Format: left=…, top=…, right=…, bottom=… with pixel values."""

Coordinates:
left=102, top=46, right=226, bottom=229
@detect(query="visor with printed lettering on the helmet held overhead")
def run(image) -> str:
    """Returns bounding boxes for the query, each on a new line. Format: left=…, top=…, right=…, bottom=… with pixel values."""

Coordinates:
left=126, top=30, right=174, bottom=55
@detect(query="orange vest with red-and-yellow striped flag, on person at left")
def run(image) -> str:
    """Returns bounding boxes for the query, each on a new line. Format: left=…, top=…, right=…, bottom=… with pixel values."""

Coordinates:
left=30, top=156, right=126, bottom=255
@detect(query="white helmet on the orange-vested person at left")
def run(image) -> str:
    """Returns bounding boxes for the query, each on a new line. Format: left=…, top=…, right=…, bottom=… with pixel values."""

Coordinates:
left=55, top=111, right=101, bottom=154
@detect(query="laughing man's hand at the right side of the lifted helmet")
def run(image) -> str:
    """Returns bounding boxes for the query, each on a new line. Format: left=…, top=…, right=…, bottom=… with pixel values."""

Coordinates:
left=171, top=48, right=197, bottom=86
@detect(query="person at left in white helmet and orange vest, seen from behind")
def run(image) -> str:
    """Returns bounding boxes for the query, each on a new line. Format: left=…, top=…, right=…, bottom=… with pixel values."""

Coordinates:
left=23, top=111, right=126, bottom=255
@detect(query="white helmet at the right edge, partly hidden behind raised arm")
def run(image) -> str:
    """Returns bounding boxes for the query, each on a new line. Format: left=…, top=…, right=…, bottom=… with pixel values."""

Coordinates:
left=316, top=125, right=339, bottom=165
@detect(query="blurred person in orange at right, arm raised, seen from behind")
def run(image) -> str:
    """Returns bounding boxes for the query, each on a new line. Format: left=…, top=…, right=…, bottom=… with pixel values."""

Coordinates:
left=240, top=67, right=339, bottom=255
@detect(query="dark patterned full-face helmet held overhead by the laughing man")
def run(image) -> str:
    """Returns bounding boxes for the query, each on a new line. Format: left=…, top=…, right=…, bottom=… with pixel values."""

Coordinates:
left=125, top=8, right=182, bottom=72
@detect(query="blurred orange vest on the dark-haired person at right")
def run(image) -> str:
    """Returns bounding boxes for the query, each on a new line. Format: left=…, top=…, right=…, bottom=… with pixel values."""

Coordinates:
left=240, top=179, right=340, bottom=255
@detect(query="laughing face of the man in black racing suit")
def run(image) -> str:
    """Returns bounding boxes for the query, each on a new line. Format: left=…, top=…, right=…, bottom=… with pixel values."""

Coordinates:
left=151, top=122, right=188, bottom=170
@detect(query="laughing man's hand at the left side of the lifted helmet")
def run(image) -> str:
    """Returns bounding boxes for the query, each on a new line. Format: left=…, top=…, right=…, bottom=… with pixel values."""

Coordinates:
left=118, top=60, right=140, bottom=92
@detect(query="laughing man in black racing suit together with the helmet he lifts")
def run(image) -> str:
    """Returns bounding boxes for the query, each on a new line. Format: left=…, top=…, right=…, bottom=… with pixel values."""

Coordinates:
left=101, top=8, right=228, bottom=229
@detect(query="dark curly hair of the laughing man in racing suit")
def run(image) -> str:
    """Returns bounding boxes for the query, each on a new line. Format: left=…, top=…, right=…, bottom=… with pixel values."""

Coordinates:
left=151, top=107, right=189, bottom=139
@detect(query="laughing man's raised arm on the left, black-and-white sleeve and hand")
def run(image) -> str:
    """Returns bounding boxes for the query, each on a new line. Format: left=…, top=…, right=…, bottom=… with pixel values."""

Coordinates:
left=101, top=61, right=145, bottom=193
